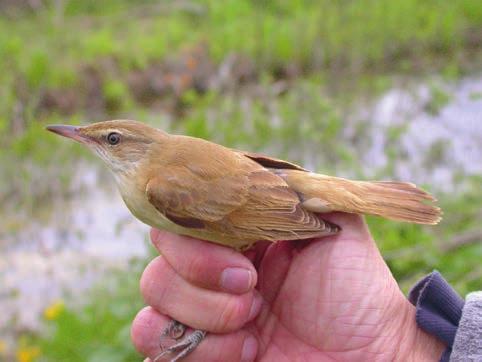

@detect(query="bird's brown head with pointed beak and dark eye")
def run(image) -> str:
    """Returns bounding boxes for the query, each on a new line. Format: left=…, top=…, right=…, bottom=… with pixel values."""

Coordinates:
left=47, top=120, right=167, bottom=175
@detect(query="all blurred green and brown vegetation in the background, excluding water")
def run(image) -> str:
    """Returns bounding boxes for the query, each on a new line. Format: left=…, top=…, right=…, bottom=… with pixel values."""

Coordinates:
left=0, top=0, right=482, bottom=361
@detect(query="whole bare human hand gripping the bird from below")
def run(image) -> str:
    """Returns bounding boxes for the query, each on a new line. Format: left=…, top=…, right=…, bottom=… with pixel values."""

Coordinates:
left=132, top=213, right=445, bottom=361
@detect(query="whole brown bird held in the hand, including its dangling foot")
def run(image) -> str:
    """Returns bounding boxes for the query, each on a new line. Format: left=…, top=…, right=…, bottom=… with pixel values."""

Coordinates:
left=46, top=120, right=441, bottom=362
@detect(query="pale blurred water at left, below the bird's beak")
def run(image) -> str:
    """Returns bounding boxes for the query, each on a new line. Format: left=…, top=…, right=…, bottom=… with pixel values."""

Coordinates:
left=0, top=165, right=148, bottom=333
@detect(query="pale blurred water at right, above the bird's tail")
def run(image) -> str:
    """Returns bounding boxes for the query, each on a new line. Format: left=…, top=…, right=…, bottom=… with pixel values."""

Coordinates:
left=362, top=76, right=482, bottom=187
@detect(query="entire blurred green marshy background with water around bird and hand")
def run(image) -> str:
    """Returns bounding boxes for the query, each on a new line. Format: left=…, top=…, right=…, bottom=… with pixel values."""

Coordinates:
left=0, top=0, right=482, bottom=362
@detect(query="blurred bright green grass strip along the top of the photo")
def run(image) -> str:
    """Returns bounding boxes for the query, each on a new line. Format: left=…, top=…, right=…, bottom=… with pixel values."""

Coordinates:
left=0, top=0, right=482, bottom=144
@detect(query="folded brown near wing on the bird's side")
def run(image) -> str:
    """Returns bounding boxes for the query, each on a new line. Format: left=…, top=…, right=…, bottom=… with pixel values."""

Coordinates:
left=146, top=144, right=337, bottom=241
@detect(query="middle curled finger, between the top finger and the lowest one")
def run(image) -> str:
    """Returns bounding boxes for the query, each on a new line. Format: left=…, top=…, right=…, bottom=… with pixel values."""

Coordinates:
left=141, top=256, right=262, bottom=333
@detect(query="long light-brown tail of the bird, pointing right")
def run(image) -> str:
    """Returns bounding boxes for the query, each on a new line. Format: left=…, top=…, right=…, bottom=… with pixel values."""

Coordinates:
left=280, top=170, right=441, bottom=225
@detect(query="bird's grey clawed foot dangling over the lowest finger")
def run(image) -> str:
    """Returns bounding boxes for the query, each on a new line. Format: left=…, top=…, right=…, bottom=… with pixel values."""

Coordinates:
left=153, top=321, right=206, bottom=362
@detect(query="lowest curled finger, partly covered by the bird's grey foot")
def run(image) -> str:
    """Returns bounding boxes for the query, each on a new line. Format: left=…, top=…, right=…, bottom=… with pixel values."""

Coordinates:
left=131, top=307, right=258, bottom=362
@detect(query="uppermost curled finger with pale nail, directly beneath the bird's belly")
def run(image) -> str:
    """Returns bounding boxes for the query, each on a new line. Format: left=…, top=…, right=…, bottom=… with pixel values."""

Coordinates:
left=151, top=229, right=257, bottom=294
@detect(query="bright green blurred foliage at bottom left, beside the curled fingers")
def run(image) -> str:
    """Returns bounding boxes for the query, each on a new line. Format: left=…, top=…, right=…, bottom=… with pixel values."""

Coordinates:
left=37, top=261, right=144, bottom=362
